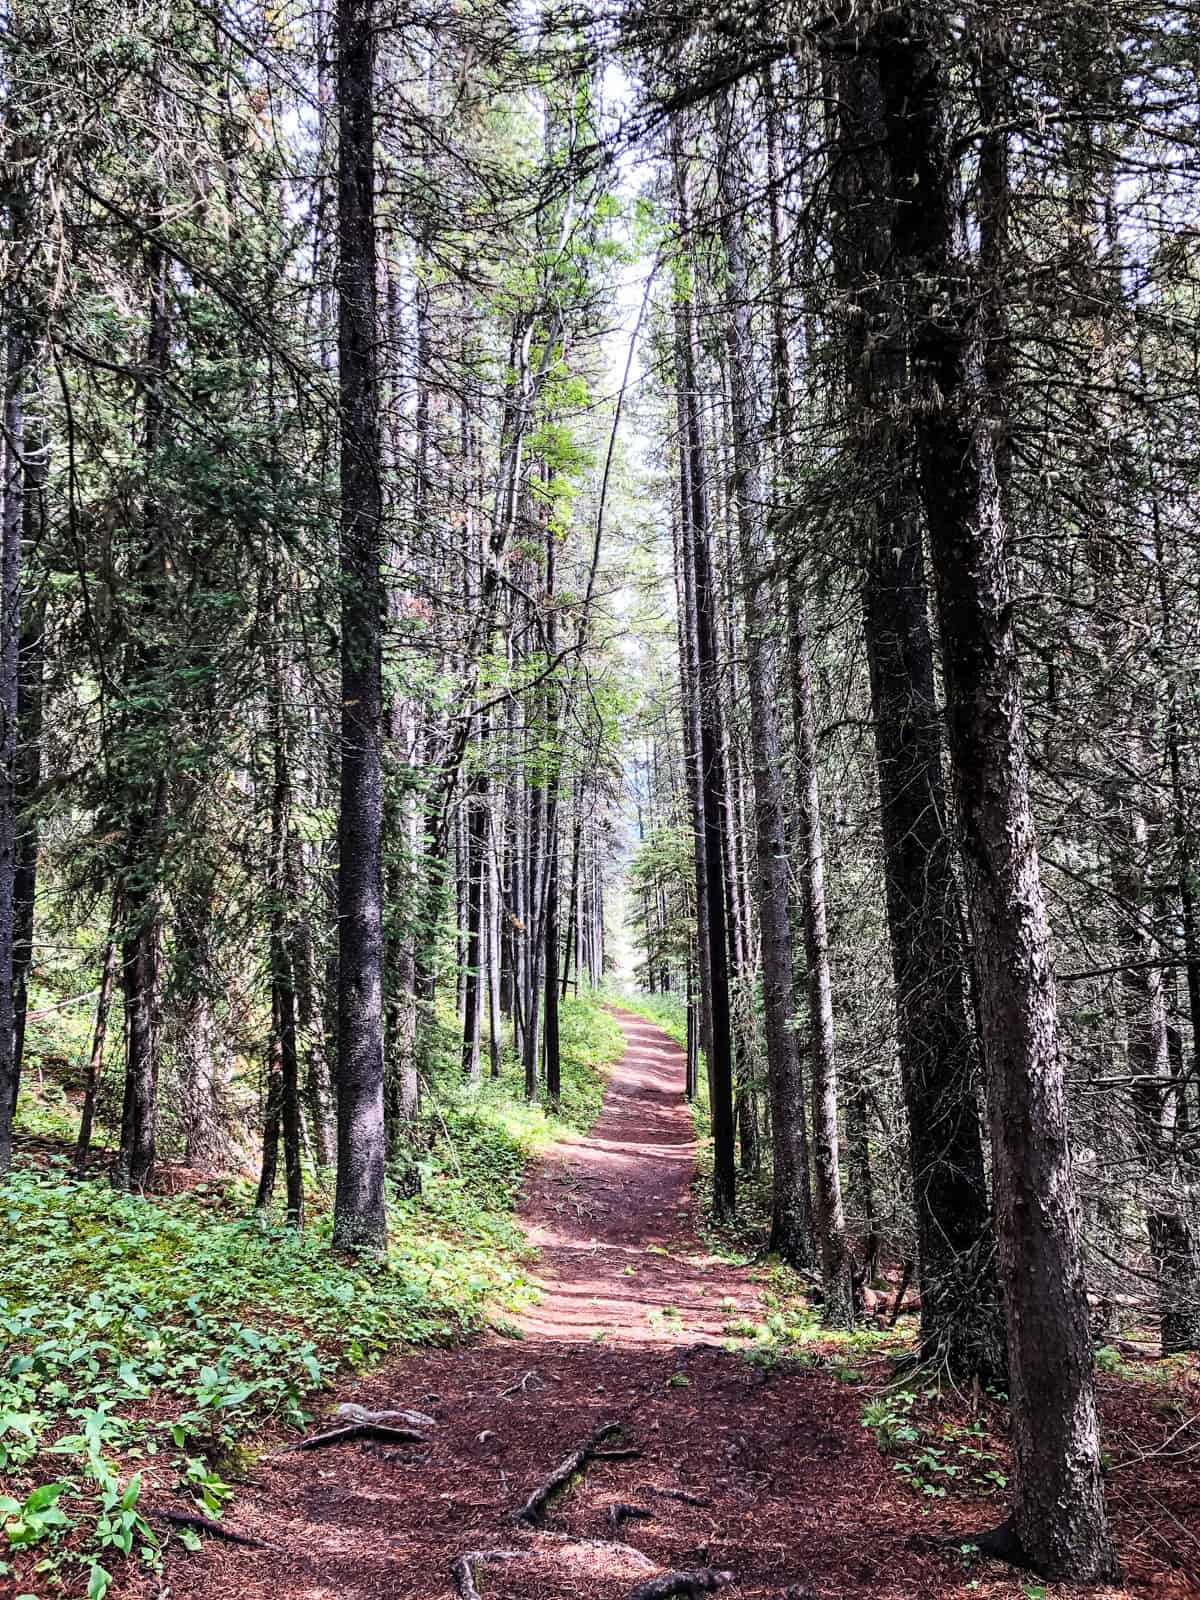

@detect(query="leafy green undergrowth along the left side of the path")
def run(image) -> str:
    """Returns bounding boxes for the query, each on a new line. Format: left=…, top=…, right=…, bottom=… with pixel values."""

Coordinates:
left=0, top=1000, right=621, bottom=1600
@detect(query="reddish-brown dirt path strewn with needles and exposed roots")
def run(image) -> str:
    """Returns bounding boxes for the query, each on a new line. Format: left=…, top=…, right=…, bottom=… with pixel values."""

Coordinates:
left=168, top=1014, right=1200, bottom=1600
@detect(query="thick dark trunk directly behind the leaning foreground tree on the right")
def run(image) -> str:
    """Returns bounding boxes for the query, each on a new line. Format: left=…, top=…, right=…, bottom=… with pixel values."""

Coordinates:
left=835, top=13, right=1005, bottom=1381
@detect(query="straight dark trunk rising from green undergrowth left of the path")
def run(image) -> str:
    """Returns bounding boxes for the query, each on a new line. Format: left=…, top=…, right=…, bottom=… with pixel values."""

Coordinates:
left=333, top=0, right=387, bottom=1250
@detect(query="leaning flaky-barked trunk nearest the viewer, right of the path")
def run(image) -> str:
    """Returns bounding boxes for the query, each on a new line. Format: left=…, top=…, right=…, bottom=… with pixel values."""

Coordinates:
left=872, top=10, right=1115, bottom=1581
